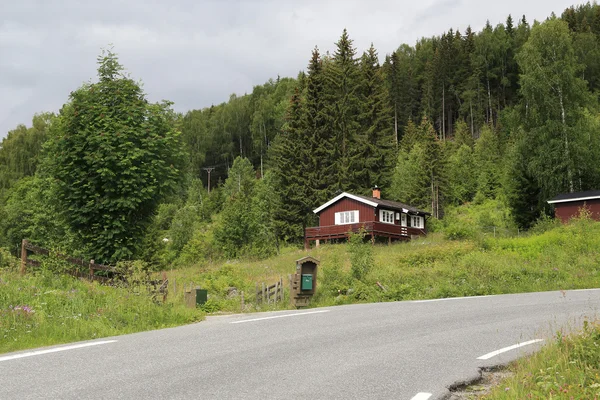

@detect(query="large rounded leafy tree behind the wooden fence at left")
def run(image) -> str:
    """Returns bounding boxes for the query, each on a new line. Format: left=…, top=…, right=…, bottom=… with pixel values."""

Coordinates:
left=47, top=51, right=182, bottom=262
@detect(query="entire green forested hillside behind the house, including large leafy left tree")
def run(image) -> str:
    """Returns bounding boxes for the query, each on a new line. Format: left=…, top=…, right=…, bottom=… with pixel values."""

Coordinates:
left=0, top=3, right=600, bottom=266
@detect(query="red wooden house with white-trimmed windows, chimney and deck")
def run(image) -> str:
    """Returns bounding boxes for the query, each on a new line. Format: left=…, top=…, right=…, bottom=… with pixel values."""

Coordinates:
left=304, top=187, right=431, bottom=248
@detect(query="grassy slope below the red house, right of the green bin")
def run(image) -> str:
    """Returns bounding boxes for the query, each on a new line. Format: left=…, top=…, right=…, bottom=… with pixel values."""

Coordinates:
left=169, top=217, right=600, bottom=312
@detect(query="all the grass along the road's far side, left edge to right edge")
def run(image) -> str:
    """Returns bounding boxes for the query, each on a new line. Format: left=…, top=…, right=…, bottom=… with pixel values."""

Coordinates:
left=0, top=216, right=600, bottom=352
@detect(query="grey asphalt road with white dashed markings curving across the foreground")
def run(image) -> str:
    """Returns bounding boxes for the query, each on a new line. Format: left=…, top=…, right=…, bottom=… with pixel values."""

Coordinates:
left=0, top=289, right=600, bottom=400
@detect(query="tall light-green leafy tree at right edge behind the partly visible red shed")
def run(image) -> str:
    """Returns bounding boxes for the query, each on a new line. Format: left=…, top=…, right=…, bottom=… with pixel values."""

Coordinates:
left=517, top=18, right=599, bottom=200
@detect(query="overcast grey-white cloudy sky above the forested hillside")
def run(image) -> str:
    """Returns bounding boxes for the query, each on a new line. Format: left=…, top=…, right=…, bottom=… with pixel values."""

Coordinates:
left=0, top=0, right=573, bottom=138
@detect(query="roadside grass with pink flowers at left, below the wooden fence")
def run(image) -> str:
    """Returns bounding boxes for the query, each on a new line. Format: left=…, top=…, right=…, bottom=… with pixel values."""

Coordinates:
left=0, top=270, right=204, bottom=353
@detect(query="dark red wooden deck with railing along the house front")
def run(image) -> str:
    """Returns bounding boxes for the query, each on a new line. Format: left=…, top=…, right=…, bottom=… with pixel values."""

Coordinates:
left=304, top=221, right=427, bottom=247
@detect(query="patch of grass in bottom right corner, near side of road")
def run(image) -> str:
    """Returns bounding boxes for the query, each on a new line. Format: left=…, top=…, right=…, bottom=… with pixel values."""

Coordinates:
left=482, top=322, right=600, bottom=400
